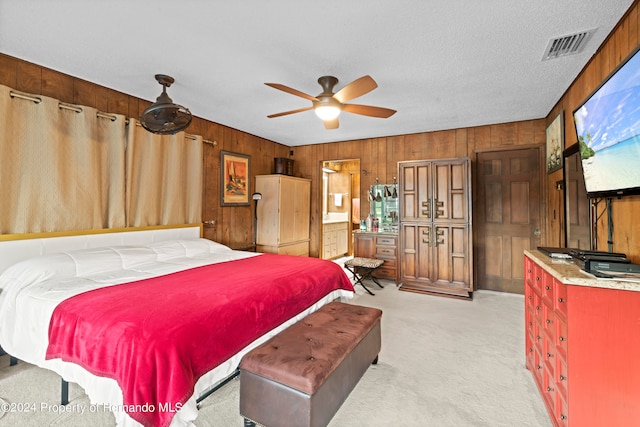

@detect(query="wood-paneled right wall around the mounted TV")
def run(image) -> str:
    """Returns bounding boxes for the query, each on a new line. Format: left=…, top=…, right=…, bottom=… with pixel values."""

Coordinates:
left=545, top=0, right=640, bottom=263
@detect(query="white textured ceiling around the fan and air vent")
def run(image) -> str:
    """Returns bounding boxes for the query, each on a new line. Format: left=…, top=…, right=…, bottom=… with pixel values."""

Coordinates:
left=0, top=0, right=633, bottom=146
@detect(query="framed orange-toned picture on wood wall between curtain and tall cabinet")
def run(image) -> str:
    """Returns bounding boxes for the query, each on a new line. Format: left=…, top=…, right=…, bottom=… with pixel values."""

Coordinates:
left=220, top=151, right=251, bottom=206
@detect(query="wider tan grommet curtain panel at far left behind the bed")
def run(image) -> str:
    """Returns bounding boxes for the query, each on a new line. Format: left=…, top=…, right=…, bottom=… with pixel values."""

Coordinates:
left=0, top=85, right=125, bottom=234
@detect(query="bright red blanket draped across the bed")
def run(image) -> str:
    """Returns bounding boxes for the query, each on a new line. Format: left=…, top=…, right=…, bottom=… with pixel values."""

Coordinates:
left=46, top=254, right=353, bottom=426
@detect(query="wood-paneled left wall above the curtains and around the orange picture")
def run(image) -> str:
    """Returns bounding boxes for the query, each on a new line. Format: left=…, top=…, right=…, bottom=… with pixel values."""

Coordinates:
left=0, top=53, right=289, bottom=247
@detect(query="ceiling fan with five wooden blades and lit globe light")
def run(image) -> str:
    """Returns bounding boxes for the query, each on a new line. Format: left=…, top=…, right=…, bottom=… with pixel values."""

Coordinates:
left=265, top=76, right=396, bottom=129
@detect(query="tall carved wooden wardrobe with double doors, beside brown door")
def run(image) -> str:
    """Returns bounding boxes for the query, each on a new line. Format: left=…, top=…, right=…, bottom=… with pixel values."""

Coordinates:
left=398, top=157, right=473, bottom=298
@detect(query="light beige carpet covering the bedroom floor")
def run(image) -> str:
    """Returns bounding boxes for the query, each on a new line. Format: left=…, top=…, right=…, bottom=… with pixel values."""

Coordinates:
left=0, top=282, right=552, bottom=427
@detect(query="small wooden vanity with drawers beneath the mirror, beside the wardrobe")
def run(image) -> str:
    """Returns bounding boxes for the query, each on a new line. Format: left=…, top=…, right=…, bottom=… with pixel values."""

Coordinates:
left=353, top=231, right=400, bottom=285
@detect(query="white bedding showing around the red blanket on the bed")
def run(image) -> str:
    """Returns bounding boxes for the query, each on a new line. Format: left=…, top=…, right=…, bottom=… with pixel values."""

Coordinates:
left=0, top=239, right=352, bottom=426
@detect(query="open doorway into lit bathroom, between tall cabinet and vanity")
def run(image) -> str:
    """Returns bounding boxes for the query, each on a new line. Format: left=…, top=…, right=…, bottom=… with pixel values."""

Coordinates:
left=320, top=159, right=360, bottom=259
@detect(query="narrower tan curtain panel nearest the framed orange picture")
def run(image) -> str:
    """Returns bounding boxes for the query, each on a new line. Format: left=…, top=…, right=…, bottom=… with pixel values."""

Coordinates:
left=126, top=119, right=203, bottom=227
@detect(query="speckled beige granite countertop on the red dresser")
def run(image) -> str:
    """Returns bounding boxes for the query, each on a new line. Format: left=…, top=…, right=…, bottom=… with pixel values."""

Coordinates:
left=524, top=250, right=640, bottom=292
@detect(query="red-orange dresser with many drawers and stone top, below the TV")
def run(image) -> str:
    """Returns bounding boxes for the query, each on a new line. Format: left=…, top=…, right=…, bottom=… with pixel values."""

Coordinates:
left=524, top=251, right=640, bottom=427
